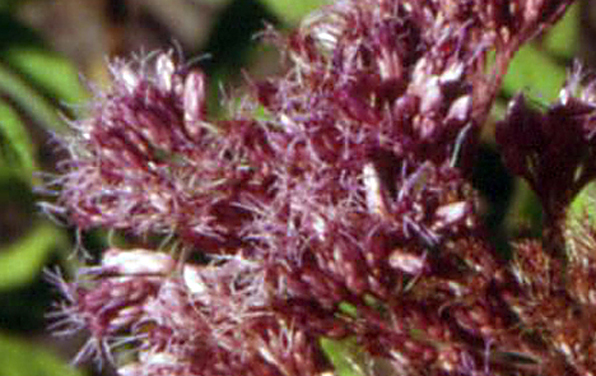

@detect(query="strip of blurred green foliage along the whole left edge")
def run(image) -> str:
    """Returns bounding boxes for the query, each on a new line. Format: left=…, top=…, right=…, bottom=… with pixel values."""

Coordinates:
left=0, top=5, right=86, bottom=376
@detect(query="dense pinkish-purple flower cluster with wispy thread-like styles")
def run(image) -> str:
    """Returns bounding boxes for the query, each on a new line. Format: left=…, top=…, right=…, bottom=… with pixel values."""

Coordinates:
left=43, top=0, right=596, bottom=376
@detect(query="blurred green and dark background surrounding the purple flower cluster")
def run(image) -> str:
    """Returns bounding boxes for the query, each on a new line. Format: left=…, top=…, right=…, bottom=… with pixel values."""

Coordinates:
left=0, top=0, right=596, bottom=376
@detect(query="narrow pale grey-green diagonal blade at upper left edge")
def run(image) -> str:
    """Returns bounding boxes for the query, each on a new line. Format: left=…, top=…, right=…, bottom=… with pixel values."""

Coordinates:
left=0, top=64, right=66, bottom=132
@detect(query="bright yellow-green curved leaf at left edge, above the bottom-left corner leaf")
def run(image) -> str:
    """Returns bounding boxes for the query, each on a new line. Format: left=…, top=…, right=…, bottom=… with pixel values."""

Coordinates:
left=0, top=222, right=67, bottom=290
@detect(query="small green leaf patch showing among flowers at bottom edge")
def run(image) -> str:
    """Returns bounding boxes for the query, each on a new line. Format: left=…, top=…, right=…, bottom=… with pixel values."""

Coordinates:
left=321, top=338, right=369, bottom=376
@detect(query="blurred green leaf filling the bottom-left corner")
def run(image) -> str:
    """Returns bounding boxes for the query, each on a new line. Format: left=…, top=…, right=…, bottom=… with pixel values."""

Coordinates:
left=0, top=334, right=82, bottom=376
